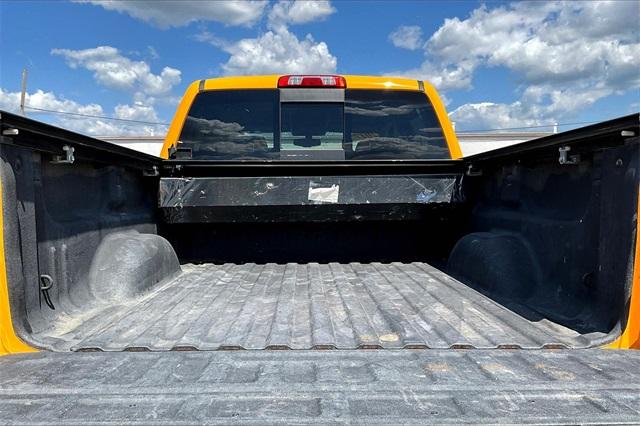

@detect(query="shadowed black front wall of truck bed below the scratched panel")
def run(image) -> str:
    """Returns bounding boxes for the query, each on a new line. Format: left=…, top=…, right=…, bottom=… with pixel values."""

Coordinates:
left=160, top=211, right=463, bottom=266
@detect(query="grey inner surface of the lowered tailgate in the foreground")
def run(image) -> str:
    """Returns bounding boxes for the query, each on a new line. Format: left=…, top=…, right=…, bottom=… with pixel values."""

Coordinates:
left=0, top=349, right=640, bottom=425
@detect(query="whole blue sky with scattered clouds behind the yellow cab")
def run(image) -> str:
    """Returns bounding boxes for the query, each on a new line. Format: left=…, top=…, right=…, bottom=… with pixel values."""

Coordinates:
left=0, top=0, right=640, bottom=135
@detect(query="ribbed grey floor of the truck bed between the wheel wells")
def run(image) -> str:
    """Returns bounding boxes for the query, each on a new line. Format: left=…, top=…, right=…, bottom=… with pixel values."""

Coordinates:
left=34, top=263, right=589, bottom=351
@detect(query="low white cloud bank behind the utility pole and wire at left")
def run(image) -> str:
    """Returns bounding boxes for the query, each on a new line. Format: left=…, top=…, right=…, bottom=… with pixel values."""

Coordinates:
left=0, top=88, right=167, bottom=136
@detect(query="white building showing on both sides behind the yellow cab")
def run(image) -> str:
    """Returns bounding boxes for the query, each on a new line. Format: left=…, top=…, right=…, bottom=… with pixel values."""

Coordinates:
left=98, top=132, right=552, bottom=156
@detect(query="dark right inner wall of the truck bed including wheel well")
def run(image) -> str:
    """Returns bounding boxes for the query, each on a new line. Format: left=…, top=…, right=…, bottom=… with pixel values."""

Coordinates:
left=447, top=138, right=639, bottom=333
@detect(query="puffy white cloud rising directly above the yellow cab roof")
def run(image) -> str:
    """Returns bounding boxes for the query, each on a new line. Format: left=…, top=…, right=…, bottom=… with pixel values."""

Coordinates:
left=221, top=27, right=337, bottom=75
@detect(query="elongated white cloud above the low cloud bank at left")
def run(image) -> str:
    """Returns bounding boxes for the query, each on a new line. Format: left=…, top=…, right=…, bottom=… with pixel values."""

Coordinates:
left=51, top=46, right=181, bottom=96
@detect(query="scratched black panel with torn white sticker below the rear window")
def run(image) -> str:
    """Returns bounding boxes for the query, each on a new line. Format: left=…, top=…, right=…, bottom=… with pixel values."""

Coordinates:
left=159, top=175, right=457, bottom=207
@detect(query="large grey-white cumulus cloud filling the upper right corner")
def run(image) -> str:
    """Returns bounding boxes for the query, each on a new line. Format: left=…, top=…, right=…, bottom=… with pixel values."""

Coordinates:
left=426, top=2, right=640, bottom=88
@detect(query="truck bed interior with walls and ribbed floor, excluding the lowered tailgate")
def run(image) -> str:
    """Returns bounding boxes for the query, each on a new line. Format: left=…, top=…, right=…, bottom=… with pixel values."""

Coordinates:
left=1, top=113, right=639, bottom=351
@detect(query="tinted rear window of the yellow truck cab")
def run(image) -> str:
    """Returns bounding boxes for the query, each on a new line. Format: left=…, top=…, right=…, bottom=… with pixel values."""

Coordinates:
left=179, top=89, right=450, bottom=161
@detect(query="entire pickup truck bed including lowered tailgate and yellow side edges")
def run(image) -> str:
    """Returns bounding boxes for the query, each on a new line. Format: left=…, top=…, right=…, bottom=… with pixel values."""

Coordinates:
left=0, top=112, right=640, bottom=424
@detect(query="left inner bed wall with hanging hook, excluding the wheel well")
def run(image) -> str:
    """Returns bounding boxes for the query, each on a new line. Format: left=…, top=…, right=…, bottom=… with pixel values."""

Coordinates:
left=0, top=145, right=157, bottom=340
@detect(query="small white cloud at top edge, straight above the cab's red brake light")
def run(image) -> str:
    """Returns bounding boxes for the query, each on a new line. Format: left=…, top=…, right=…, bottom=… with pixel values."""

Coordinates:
left=269, top=0, right=336, bottom=29
